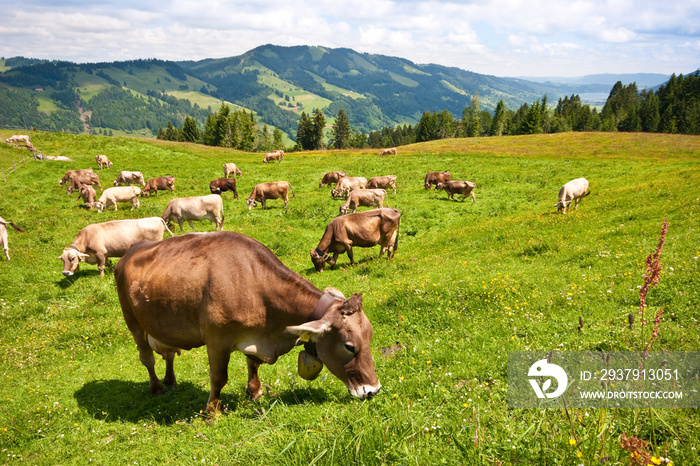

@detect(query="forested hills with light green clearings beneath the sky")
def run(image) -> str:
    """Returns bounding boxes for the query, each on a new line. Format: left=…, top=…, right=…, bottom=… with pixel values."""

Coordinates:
left=0, top=45, right=680, bottom=138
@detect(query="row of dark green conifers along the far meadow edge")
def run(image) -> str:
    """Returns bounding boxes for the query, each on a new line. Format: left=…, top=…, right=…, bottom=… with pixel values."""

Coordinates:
left=158, top=70, right=700, bottom=151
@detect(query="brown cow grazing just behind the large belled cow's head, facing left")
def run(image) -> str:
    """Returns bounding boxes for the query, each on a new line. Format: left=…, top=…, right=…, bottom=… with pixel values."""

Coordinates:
left=311, top=209, right=401, bottom=272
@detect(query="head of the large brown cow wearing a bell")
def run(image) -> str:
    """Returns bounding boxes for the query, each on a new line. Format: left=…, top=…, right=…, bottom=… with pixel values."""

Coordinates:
left=287, top=293, right=382, bottom=398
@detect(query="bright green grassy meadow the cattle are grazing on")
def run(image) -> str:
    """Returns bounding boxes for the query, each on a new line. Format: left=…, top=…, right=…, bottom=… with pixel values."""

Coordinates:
left=0, top=130, right=700, bottom=465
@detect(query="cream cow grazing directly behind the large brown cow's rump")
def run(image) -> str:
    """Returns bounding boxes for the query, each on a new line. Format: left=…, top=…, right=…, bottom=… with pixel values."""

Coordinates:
left=59, top=217, right=172, bottom=277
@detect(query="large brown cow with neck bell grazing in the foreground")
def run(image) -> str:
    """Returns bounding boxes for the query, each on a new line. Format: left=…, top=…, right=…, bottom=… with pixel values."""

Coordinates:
left=114, top=231, right=381, bottom=413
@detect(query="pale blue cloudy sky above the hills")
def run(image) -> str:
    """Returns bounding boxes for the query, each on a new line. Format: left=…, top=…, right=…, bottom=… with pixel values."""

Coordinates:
left=0, top=0, right=700, bottom=76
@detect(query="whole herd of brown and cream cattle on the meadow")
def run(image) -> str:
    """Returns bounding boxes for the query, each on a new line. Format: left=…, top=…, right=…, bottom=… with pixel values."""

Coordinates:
left=0, top=138, right=590, bottom=412
